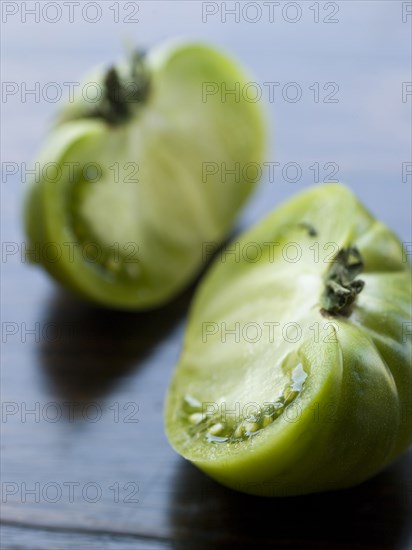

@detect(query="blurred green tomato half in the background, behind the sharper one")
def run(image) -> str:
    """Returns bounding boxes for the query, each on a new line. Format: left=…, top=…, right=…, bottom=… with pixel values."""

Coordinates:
left=26, top=44, right=265, bottom=309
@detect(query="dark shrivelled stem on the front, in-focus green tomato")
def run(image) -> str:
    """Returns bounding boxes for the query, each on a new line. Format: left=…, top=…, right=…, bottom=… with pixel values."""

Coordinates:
left=321, top=247, right=365, bottom=315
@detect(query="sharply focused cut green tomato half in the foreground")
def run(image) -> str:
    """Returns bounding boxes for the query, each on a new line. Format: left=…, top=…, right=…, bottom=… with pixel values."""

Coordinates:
left=165, top=184, right=412, bottom=496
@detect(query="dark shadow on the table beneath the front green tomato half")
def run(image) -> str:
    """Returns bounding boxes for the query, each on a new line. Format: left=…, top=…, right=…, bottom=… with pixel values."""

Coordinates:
left=170, top=452, right=412, bottom=550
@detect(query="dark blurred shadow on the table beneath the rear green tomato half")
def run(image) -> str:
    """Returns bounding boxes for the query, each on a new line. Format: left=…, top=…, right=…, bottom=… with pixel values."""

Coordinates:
left=40, top=286, right=194, bottom=402
